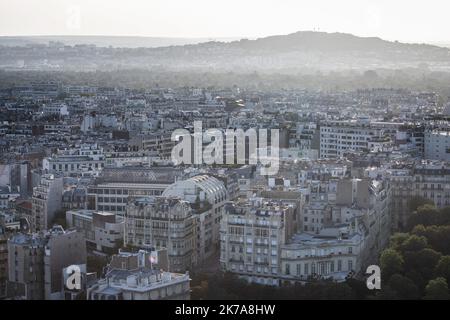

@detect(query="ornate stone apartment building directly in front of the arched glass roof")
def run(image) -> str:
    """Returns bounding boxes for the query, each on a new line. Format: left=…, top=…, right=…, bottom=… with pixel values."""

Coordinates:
left=124, top=197, right=197, bottom=272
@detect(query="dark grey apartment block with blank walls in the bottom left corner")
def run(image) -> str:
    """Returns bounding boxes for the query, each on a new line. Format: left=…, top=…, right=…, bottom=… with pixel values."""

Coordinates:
left=8, top=226, right=86, bottom=300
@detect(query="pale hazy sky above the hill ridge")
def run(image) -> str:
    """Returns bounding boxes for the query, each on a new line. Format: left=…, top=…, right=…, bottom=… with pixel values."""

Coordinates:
left=0, top=0, right=450, bottom=42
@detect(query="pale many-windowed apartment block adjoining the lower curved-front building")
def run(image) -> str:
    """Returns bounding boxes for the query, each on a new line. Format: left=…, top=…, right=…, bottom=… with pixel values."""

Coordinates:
left=220, top=198, right=295, bottom=286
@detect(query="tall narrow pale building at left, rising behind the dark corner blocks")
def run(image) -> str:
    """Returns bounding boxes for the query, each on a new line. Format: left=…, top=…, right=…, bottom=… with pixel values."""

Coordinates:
left=31, top=174, right=63, bottom=231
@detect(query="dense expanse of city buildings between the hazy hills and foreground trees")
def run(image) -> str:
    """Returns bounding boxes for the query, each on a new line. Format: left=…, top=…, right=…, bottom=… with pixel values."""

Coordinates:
left=0, top=78, right=450, bottom=300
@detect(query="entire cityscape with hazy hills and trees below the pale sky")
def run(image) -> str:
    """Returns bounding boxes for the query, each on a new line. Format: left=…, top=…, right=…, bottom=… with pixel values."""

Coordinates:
left=0, top=0, right=450, bottom=304
